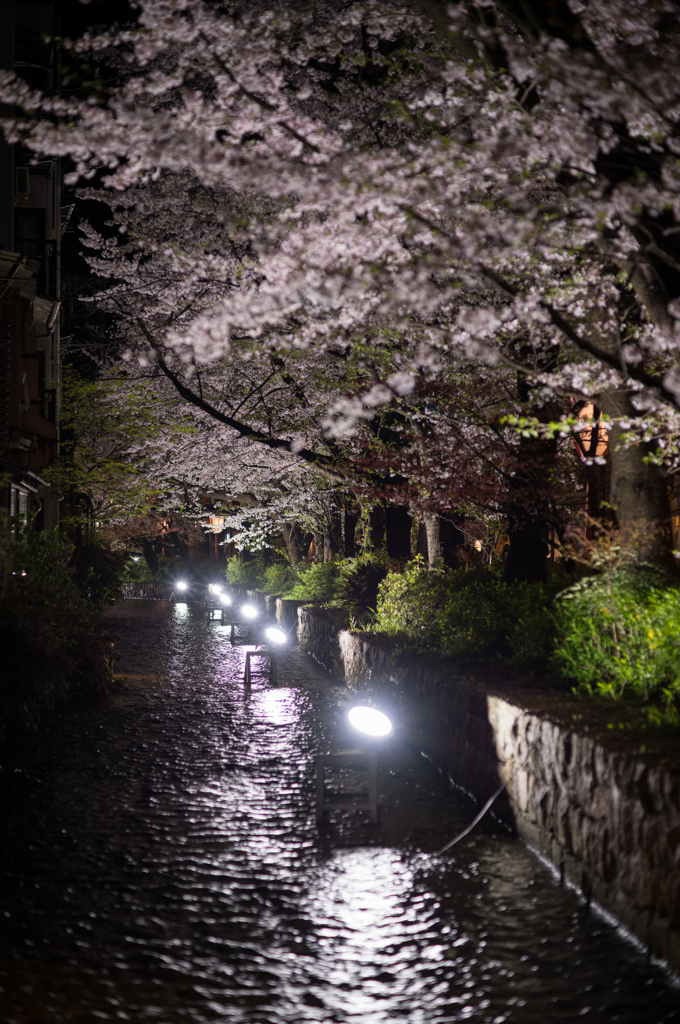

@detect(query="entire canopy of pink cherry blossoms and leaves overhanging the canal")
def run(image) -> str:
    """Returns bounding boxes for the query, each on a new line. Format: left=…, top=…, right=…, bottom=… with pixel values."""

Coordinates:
left=7, top=0, right=680, bottom=565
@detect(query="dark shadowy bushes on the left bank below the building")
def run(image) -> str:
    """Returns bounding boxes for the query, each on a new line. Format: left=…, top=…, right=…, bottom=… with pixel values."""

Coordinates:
left=0, top=532, right=113, bottom=741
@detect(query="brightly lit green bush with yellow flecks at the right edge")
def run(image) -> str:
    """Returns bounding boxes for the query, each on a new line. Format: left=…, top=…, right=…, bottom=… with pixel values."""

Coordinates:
left=553, top=567, right=680, bottom=702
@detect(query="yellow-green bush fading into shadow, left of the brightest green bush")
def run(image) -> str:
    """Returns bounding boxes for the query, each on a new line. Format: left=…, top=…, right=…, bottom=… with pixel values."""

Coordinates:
left=376, top=559, right=563, bottom=667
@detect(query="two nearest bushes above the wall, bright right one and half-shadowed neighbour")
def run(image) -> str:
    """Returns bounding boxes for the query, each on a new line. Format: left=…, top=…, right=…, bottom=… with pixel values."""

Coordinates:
left=375, top=559, right=680, bottom=700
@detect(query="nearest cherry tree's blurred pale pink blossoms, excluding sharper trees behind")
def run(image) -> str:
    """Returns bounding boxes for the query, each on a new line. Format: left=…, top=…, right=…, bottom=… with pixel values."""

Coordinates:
left=2, top=0, right=680, bottom=558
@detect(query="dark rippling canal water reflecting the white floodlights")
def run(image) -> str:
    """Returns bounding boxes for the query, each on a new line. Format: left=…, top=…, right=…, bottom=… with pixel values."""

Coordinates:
left=0, top=602, right=680, bottom=1024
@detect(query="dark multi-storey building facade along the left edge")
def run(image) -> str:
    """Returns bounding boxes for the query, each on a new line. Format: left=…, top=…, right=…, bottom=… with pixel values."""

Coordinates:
left=0, top=6, right=62, bottom=529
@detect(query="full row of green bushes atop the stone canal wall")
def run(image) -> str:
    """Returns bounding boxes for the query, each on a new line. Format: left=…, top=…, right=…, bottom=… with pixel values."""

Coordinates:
left=232, top=552, right=680, bottom=727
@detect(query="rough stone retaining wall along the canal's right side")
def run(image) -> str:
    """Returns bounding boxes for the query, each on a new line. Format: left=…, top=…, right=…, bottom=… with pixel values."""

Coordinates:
left=298, top=607, right=680, bottom=971
